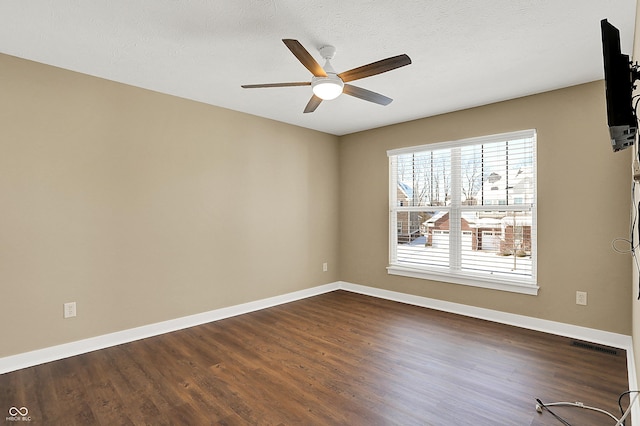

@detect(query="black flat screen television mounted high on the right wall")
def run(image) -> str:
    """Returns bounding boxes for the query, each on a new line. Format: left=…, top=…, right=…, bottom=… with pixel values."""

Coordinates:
left=600, top=19, right=638, bottom=152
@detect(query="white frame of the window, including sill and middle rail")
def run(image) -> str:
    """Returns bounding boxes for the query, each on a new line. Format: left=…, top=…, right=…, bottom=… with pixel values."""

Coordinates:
left=387, top=129, right=539, bottom=295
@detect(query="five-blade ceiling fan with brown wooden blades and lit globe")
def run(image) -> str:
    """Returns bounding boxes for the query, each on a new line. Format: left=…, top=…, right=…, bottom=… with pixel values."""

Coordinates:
left=241, top=39, right=411, bottom=113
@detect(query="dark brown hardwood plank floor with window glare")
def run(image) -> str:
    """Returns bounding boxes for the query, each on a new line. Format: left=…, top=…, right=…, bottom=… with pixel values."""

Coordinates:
left=0, top=291, right=630, bottom=426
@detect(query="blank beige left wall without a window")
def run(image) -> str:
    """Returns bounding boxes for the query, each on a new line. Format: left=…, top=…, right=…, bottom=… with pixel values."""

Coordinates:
left=0, top=55, right=339, bottom=357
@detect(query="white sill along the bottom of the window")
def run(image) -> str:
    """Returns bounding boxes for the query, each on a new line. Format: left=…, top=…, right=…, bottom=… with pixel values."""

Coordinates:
left=387, top=265, right=540, bottom=296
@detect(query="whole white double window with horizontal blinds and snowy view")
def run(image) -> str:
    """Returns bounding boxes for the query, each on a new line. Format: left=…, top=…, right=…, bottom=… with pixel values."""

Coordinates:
left=387, top=130, right=538, bottom=294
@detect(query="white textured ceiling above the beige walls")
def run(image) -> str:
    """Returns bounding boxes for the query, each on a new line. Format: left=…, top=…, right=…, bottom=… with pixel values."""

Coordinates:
left=0, top=0, right=636, bottom=135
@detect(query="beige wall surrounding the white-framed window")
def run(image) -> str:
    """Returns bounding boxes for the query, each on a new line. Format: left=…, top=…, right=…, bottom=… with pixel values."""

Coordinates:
left=340, top=81, right=631, bottom=334
